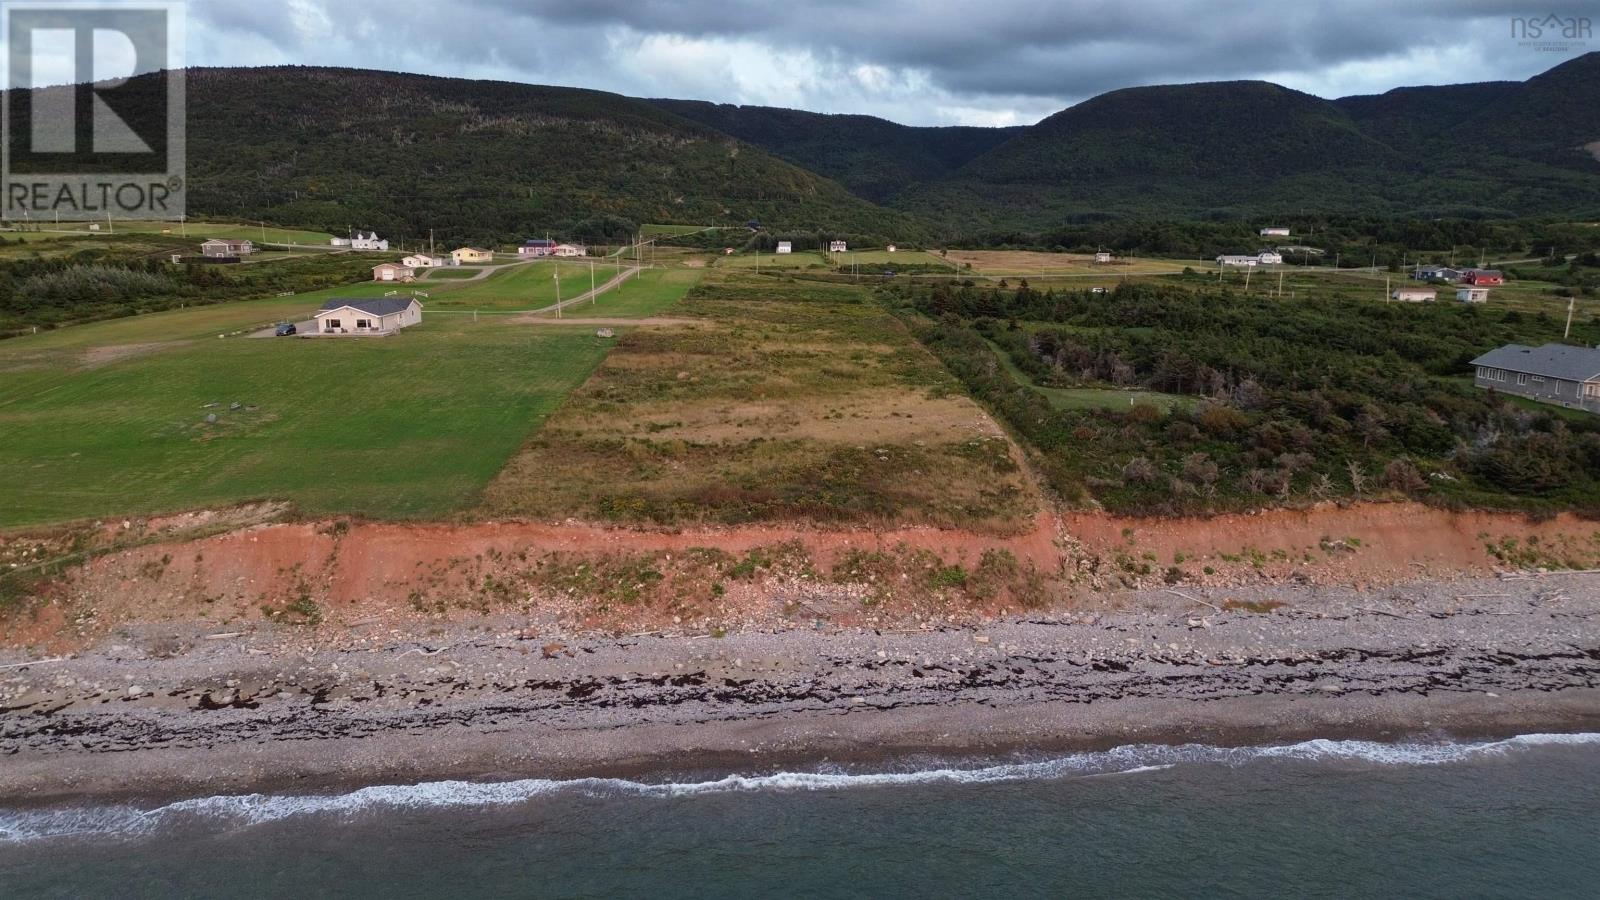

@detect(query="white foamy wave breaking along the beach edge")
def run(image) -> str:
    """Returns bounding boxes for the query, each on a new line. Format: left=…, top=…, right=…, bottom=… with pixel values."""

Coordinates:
left=0, top=733, right=1600, bottom=844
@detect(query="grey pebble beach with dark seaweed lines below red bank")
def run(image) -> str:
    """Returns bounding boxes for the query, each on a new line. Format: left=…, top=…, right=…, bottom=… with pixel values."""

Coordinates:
left=0, top=575, right=1600, bottom=807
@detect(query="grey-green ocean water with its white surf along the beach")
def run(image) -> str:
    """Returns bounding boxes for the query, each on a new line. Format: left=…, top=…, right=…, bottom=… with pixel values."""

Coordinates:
left=0, top=735, right=1600, bottom=898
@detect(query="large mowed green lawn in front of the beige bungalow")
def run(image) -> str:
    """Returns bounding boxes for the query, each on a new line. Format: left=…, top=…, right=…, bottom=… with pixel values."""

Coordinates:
left=0, top=310, right=610, bottom=527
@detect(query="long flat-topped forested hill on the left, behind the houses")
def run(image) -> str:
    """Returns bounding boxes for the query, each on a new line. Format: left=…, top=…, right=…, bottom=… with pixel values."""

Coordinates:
left=178, top=67, right=917, bottom=242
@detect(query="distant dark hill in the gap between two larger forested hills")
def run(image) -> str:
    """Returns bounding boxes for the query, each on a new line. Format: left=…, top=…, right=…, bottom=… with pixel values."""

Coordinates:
left=650, top=99, right=1022, bottom=203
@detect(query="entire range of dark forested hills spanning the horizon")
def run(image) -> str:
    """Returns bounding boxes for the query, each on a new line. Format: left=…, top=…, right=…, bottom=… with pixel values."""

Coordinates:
left=37, top=53, right=1600, bottom=242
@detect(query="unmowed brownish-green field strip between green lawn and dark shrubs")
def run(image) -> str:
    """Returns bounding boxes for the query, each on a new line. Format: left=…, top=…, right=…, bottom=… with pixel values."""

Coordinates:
left=483, top=271, right=1040, bottom=532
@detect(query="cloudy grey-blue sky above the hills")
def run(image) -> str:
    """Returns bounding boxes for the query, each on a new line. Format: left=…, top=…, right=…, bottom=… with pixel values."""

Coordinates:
left=189, top=0, right=1600, bottom=125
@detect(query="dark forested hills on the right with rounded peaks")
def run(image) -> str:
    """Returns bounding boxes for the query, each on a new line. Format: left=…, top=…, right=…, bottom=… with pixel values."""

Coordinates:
left=896, top=53, right=1600, bottom=227
